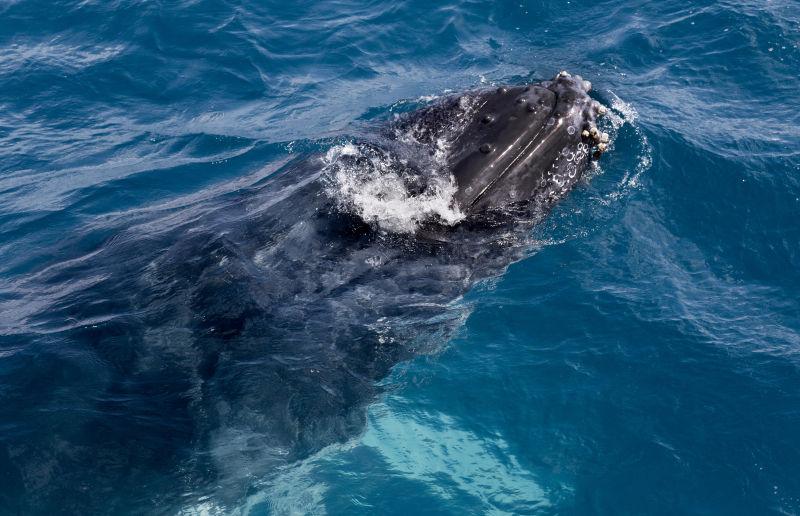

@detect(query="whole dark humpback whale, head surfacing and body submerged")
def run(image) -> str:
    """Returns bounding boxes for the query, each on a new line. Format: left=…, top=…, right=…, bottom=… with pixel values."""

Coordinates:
left=0, top=73, right=605, bottom=514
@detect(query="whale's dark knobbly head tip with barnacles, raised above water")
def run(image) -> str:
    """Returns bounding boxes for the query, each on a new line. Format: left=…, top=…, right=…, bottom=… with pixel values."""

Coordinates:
left=438, top=72, right=608, bottom=213
